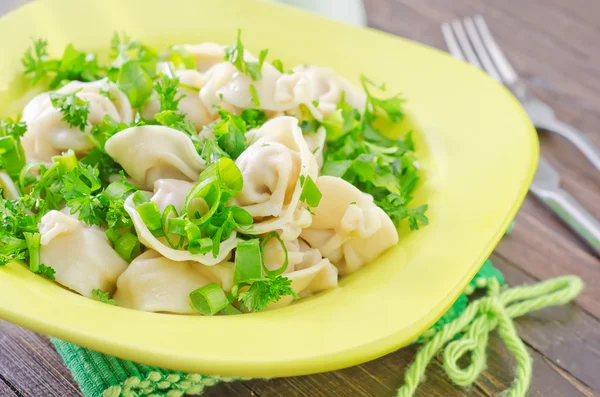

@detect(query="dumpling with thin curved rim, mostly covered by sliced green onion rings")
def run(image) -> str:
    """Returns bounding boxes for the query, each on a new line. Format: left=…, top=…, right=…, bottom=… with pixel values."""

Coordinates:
left=124, top=179, right=239, bottom=266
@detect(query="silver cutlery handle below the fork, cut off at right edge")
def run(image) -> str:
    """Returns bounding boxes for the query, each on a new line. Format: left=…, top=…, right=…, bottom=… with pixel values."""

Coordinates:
left=531, top=186, right=600, bottom=256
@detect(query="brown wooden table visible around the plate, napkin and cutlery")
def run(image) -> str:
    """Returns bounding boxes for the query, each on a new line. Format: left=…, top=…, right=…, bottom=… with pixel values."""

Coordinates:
left=0, top=0, right=600, bottom=397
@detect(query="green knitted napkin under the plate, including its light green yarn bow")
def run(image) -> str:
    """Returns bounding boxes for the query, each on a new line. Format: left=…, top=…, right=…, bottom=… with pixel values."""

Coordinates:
left=53, top=260, right=583, bottom=397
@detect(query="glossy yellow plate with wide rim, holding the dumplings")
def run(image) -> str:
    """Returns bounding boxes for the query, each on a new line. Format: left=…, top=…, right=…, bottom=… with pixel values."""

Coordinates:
left=0, top=0, right=538, bottom=377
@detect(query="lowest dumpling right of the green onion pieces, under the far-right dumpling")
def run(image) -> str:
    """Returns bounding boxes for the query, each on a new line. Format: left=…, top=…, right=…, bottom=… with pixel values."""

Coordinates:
left=264, top=235, right=338, bottom=309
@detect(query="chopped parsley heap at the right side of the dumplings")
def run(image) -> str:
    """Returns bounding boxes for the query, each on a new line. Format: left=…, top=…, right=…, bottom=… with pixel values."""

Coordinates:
left=322, top=77, right=428, bottom=229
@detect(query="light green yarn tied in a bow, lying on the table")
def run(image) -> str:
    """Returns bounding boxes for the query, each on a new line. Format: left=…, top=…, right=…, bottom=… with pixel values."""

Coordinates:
left=396, top=276, right=583, bottom=397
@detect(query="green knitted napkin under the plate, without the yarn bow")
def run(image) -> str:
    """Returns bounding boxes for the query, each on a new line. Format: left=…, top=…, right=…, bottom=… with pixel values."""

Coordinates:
left=52, top=260, right=504, bottom=397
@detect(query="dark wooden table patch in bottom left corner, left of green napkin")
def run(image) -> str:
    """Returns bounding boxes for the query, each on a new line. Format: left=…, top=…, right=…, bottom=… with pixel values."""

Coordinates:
left=0, top=321, right=82, bottom=397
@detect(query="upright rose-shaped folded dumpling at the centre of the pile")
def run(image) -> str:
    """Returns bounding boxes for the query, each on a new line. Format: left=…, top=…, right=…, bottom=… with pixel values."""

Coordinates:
left=232, top=116, right=319, bottom=240
